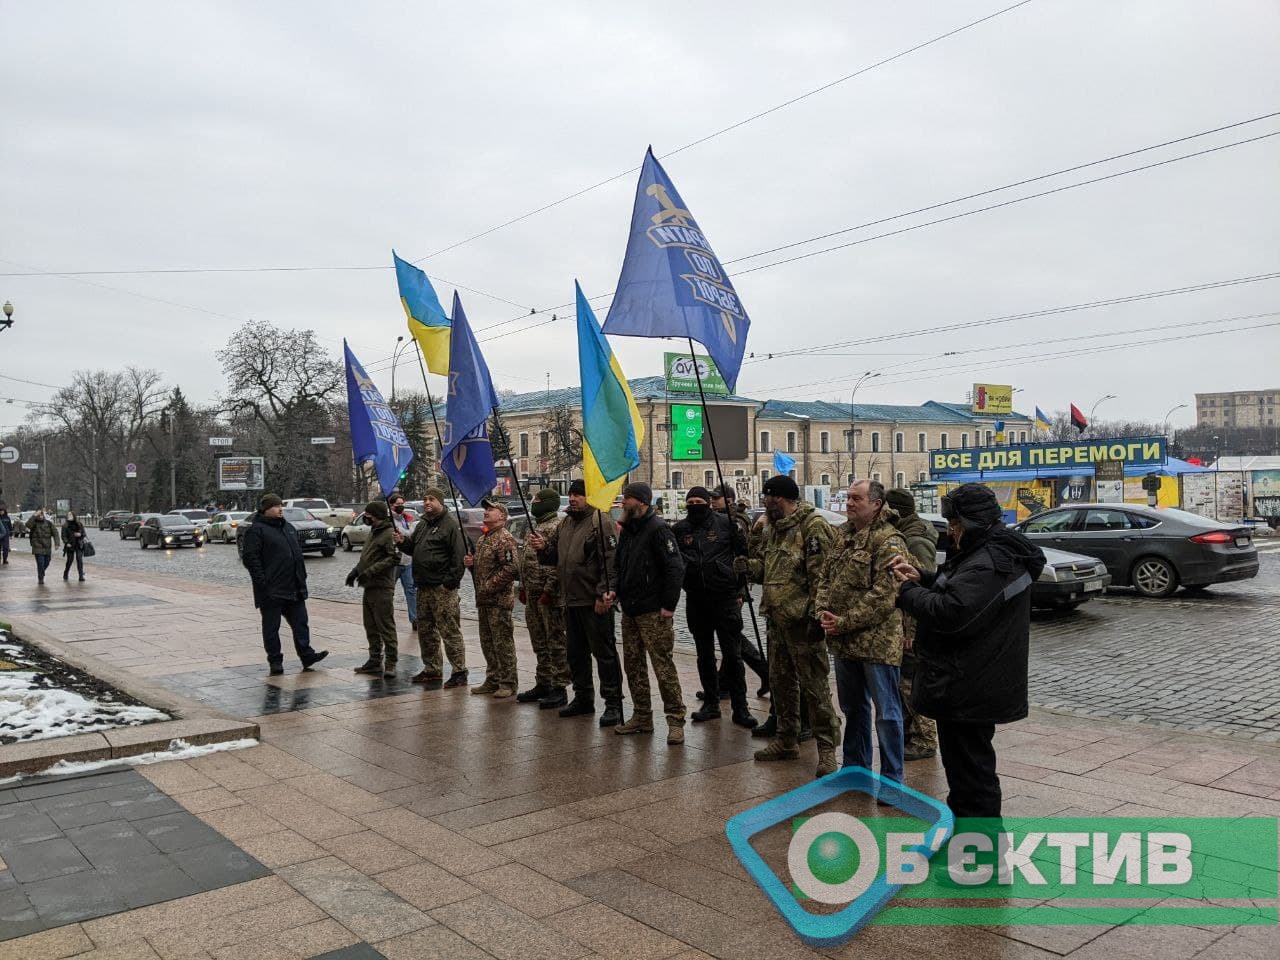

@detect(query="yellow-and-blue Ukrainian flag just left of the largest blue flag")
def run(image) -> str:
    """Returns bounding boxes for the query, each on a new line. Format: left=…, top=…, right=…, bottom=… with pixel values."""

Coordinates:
left=573, top=280, right=644, bottom=511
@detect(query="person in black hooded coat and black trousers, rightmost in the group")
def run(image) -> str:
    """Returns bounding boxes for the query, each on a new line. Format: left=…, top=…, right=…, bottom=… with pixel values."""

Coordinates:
left=893, top=484, right=1044, bottom=817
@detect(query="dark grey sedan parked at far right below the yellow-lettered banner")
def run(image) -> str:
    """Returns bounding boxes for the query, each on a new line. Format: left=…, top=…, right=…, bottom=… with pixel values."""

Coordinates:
left=1016, top=503, right=1258, bottom=596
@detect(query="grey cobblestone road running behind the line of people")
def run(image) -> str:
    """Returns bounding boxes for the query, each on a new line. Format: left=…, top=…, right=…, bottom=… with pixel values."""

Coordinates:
left=82, top=532, right=1280, bottom=741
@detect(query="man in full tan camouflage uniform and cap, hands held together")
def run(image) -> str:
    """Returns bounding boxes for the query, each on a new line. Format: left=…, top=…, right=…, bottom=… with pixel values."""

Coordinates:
left=462, top=500, right=518, bottom=700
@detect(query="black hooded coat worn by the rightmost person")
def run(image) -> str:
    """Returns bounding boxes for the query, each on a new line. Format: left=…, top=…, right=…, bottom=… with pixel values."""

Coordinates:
left=897, top=522, right=1044, bottom=723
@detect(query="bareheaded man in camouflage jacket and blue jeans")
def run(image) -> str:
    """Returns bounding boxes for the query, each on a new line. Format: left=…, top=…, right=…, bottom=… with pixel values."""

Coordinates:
left=818, top=480, right=908, bottom=783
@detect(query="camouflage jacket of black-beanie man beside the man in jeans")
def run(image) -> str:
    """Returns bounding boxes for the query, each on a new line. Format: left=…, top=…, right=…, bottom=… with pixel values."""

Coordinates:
left=748, top=503, right=836, bottom=623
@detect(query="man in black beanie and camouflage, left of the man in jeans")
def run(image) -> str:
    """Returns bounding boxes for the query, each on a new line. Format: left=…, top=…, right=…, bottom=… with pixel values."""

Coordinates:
left=737, top=476, right=840, bottom=777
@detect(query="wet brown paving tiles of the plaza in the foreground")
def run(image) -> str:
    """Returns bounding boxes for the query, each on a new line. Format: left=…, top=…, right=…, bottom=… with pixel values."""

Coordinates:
left=0, top=566, right=1280, bottom=960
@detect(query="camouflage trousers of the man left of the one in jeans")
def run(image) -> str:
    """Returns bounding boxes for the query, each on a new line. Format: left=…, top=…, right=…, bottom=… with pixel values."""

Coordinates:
left=769, top=618, right=840, bottom=750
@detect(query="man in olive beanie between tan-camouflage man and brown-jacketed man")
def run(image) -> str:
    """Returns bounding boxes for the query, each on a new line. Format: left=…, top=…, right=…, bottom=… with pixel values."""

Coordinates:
left=516, top=486, right=570, bottom=710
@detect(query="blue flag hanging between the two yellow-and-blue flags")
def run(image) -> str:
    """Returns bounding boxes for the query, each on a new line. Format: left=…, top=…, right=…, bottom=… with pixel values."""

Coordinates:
left=440, top=291, right=498, bottom=507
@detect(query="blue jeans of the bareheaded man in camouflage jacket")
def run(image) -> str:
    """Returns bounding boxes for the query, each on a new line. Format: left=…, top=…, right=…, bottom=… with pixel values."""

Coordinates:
left=836, top=657, right=902, bottom=783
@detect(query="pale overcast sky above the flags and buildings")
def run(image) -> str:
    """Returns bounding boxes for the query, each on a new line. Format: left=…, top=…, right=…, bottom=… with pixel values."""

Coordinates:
left=0, top=0, right=1280, bottom=426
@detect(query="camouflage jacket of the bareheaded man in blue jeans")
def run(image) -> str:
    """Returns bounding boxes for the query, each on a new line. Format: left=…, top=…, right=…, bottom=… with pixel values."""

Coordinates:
left=818, top=512, right=908, bottom=667
